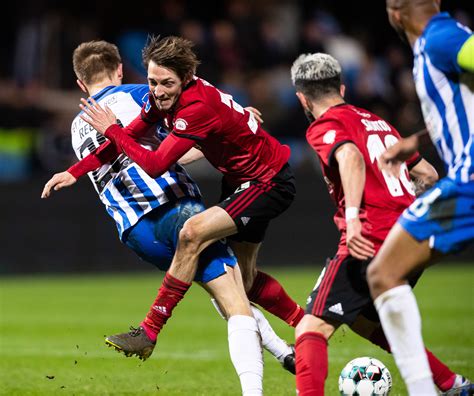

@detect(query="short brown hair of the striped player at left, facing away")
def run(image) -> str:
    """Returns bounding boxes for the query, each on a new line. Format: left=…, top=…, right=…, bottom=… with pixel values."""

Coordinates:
left=72, top=40, right=122, bottom=85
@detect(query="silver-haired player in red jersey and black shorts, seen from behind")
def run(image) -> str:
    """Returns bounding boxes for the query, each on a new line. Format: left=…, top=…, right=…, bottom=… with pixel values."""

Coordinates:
left=291, top=53, right=464, bottom=396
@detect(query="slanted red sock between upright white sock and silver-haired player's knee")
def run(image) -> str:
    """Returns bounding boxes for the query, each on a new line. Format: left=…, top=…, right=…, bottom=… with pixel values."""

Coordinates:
left=247, top=271, right=304, bottom=327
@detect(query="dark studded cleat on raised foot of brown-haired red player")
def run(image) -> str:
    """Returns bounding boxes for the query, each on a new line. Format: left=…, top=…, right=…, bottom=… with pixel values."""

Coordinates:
left=105, top=326, right=155, bottom=361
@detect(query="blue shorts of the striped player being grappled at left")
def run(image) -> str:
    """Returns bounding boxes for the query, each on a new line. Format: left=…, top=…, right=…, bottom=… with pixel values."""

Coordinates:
left=125, top=198, right=237, bottom=283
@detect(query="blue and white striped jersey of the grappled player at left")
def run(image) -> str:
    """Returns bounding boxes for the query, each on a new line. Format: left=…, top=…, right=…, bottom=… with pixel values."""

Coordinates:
left=71, top=84, right=201, bottom=239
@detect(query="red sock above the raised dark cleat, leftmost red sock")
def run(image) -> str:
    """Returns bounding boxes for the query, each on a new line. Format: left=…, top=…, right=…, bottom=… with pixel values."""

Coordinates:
left=141, top=272, right=191, bottom=341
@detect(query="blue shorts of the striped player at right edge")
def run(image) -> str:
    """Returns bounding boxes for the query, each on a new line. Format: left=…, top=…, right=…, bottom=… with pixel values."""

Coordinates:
left=398, top=178, right=474, bottom=253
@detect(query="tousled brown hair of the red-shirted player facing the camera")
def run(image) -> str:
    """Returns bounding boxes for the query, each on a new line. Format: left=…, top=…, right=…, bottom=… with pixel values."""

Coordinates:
left=142, top=36, right=200, bottom=81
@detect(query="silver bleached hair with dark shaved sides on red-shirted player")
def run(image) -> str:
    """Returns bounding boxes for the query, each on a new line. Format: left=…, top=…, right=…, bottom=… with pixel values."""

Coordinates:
left=291, top=52, right=341, bottom=100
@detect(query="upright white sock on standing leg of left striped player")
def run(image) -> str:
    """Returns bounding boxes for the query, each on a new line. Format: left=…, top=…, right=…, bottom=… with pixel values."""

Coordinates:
left=227, top=315, right=263, bottom=396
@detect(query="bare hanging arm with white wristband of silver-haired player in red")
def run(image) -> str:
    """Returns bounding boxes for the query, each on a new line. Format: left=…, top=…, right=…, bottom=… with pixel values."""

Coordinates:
left=334, top=143, right=375, bottom=260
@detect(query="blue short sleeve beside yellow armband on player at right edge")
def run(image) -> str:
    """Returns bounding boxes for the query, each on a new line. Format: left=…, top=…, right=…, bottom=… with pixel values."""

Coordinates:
left=425, top=21, right=472, bottom=73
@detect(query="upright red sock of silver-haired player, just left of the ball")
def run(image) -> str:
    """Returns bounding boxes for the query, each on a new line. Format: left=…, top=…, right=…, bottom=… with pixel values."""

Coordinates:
left=295, top=331, right=328, bottom=396
